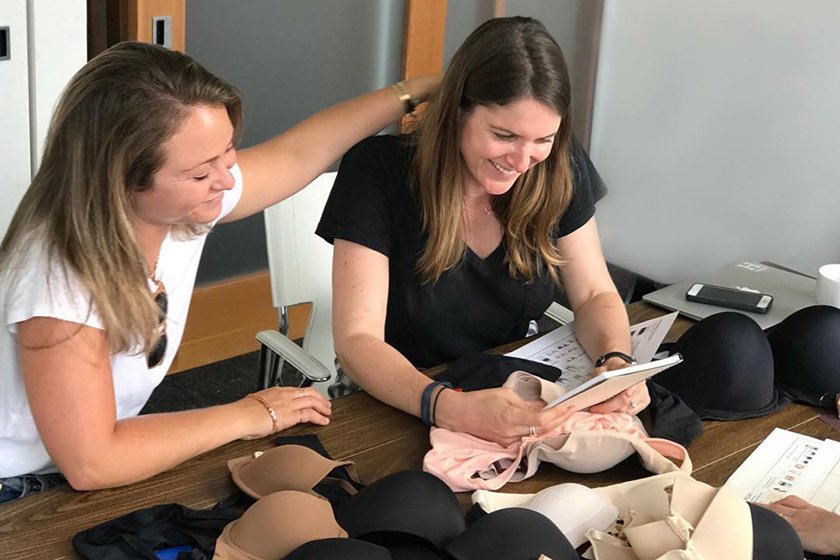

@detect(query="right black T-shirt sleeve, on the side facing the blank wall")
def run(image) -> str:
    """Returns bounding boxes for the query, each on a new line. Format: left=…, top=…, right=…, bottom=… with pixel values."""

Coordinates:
left=552, top=138, right=607, bottom=239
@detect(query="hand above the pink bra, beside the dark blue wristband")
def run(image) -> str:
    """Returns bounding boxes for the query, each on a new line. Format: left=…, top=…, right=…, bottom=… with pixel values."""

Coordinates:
left=435, top=387, right=575, bottom=447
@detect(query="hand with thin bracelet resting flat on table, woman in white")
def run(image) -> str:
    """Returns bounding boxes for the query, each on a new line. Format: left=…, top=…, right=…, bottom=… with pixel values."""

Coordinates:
left=239, top=387, right=332, bottom=439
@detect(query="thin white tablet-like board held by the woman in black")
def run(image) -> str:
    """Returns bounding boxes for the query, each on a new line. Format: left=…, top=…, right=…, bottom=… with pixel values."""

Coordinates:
left=545, top=354, right=682, bottom=410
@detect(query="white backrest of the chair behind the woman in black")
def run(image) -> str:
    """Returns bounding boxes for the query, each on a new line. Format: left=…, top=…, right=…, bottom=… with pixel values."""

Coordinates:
left=264, top=172, right=336, bottom=391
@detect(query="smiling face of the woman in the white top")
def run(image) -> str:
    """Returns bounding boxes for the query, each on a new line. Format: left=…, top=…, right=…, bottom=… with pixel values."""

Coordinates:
left=134, top=105, right=236, bottom=226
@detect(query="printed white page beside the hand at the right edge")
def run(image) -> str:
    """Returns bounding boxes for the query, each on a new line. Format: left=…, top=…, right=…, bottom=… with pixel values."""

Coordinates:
left=724, top=428, right=830, bottom=503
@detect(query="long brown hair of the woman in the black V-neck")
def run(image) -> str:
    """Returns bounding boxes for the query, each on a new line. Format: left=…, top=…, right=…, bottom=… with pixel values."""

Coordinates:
left=412, top=17, right=572, bottom=282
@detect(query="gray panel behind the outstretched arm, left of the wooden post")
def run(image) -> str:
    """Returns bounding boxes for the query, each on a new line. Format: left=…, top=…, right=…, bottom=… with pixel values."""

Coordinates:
left=186, top=0, right=405, bottom=283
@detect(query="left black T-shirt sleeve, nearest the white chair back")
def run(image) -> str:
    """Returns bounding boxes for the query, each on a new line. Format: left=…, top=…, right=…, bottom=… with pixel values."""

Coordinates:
left=315, top=136, right=407, bottom=257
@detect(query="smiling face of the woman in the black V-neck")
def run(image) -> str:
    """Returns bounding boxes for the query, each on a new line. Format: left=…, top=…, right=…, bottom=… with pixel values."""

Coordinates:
left=460, top=98, right=561, bottom=196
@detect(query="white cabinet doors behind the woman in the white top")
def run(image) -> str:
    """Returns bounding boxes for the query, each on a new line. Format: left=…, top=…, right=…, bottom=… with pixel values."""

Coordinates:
left=0, top=0, right=87, bottom=237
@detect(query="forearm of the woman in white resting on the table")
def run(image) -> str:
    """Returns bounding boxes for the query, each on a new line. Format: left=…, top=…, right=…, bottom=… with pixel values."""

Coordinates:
left=58, top=400, right=256, bottom=490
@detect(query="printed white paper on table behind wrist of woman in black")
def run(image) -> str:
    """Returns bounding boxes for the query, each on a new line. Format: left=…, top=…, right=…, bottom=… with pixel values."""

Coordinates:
left=506, top=312, right=678, bottom=389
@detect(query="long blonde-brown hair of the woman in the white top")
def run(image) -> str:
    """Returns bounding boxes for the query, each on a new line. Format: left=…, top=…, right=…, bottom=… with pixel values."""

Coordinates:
left=0, top=42, right=242, bottom=352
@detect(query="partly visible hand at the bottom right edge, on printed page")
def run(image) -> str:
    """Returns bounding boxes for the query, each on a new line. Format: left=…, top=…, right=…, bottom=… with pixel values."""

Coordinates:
left=762, top=496, right=840, bottom=555
